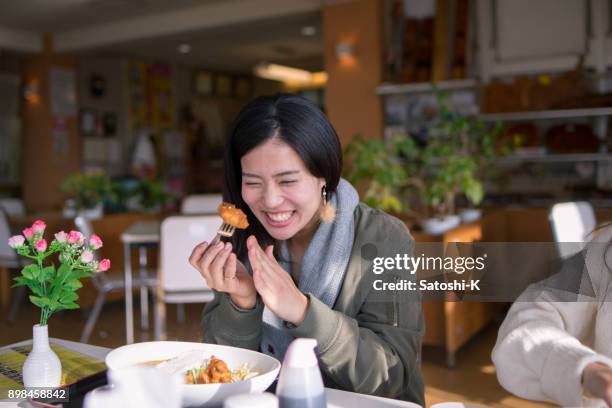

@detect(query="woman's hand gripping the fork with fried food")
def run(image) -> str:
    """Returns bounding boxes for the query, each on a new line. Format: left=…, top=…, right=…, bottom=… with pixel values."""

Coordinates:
left=189, top=241, right=257, bottom=309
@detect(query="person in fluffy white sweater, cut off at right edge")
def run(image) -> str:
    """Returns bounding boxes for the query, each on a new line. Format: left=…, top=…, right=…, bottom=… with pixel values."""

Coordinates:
left=492, top=227, right=612, bottom=407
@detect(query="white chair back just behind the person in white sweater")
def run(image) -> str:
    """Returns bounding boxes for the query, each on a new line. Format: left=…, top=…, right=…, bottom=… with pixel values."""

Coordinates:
left=548, top=201, right=596, bottom=259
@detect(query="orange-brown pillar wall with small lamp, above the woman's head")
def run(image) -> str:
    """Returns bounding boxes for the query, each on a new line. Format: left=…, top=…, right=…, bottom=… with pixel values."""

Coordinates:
left=323, top=0, right=383, bottom=145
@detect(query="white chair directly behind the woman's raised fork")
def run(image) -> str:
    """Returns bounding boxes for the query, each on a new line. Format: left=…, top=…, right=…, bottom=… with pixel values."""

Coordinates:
left=155, top=215, right=222, bottom=340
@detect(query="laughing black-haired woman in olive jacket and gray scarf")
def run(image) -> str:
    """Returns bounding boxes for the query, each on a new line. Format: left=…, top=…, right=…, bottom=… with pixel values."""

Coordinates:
left=190, top=95, right=424, bottom=404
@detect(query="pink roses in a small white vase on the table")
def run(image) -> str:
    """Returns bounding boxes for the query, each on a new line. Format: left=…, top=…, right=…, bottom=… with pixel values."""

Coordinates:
left=8, top=220, right=110, bottom=387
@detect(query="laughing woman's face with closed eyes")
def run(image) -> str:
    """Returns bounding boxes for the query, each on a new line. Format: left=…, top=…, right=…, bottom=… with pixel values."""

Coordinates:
left=240, top=138, right=325, bottom=240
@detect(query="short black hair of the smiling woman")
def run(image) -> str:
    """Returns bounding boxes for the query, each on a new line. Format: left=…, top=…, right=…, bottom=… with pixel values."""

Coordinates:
left=223, top=93, right=342, bottom=258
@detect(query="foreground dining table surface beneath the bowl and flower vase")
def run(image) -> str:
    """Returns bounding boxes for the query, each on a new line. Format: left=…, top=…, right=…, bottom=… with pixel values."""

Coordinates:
left=0, top=337, right=420, bottom=408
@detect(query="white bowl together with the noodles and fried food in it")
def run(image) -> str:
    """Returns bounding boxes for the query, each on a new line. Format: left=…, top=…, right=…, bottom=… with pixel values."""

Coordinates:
left=105, top=341, right=281, bottom=407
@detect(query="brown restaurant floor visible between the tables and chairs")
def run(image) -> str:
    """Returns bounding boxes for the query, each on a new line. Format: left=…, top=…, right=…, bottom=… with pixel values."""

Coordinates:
left=0, top=302, right=548, bottom=407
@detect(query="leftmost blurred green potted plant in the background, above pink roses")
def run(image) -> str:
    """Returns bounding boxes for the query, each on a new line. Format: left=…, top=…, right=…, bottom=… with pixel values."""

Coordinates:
left=60, top=173, right=113, bottom=219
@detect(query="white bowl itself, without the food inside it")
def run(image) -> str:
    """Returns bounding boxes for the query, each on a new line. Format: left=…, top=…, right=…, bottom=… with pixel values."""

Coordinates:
left=106, top=341, right=281, bottom=407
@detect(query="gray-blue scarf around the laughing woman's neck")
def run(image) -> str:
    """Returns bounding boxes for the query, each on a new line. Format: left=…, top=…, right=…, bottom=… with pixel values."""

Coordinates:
left=261, top=179, right=359, bottom=361
